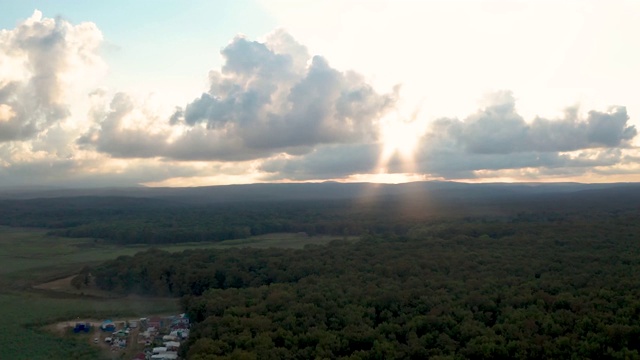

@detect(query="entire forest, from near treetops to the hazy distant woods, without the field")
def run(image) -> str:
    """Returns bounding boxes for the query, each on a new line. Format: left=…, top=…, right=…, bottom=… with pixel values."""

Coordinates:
left=5, top=184, right=640, bottom=360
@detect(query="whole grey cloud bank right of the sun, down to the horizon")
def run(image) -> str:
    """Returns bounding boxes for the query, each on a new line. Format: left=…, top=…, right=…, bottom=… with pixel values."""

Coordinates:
left=408, top=92, right=637, bottom=178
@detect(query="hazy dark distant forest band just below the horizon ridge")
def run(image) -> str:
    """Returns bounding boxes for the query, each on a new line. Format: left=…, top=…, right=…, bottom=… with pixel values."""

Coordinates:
left=0, top=184, right=640, bottom=244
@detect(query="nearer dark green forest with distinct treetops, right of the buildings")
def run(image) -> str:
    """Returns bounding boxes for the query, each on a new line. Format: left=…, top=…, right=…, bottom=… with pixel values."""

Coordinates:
left=87, top=209, right=640, bottom=359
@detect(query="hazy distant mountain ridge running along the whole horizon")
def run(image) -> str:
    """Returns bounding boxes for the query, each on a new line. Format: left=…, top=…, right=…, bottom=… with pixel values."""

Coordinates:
left=0, top=181, right=640, bottom=204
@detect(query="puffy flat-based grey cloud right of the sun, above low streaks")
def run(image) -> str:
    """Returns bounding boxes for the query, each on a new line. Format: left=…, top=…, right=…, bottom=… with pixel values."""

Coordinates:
left=431, top=92, right=637, bottom=154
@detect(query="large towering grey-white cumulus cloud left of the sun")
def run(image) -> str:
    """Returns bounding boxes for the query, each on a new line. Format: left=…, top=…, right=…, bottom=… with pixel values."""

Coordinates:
left=79, top=30, right=397, bottom=161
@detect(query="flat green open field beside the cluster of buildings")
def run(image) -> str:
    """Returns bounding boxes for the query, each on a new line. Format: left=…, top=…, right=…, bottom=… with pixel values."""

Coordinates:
left=0, top=227, right=355, bottom=360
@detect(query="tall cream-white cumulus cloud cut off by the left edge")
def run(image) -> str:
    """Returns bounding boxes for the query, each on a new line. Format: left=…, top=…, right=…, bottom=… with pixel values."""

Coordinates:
left=0, top=10, right=102, bottom=142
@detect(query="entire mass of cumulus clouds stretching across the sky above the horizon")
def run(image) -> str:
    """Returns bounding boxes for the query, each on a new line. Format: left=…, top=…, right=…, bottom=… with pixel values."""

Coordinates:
left=0, top=11, right=640, bottom=185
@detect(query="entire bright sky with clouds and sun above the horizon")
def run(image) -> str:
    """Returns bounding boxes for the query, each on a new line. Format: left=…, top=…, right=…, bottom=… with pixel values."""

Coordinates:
left=0, top=0, right=640, bottom=187
